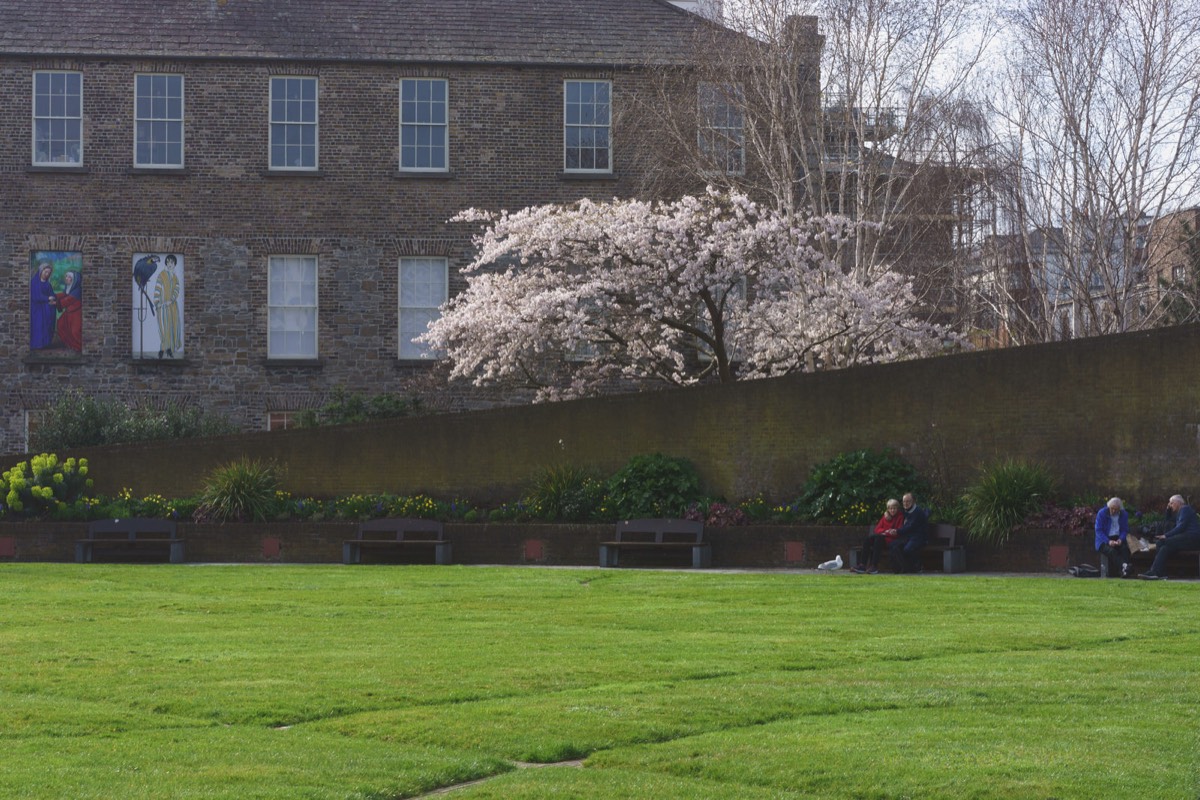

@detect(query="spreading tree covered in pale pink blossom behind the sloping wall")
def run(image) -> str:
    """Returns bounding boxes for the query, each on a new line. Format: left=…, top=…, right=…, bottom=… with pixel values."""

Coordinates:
left=421, top=188, right=958, bottom=399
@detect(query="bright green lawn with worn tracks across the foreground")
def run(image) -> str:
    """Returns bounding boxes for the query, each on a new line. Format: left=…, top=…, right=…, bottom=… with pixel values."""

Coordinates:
left=0, top=564, right=1200, bottom=800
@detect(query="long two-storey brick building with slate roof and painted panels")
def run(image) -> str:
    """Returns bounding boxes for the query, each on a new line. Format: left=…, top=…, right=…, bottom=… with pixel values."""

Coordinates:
left=0, top=0, right=782, bottom=452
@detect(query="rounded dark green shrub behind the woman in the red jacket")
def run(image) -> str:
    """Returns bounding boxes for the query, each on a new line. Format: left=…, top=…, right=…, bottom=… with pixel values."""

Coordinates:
left=797, top=450, right=929, bottom=525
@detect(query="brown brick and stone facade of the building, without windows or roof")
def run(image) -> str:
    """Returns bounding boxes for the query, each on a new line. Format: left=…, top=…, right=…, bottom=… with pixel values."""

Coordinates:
left=0, top=58, right=662, bottom=452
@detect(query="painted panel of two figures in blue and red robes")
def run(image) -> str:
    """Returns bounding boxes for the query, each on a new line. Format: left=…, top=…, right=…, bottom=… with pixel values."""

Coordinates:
left=29, top=249, right=83, bottom=355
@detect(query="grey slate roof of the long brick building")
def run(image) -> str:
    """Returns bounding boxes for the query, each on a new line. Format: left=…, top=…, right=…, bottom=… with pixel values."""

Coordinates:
left=0, top=0, right=710, bottom=66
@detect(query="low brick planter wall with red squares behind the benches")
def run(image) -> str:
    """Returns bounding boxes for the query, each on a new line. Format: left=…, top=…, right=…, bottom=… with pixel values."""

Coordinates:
left=0, top=522, right=1142, bottom=577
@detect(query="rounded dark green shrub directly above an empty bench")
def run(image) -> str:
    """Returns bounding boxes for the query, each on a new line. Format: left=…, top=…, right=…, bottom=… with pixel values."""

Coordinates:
left=605, top=453, right=703, bottom=519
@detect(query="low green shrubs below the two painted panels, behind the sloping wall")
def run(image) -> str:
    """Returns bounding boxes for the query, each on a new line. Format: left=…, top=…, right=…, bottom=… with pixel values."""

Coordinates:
left=31, top=390, right=238, bottom=450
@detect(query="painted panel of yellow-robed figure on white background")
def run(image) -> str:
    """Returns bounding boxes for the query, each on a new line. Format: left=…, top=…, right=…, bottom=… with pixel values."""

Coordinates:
left=133, top=253, right=184, bottom=359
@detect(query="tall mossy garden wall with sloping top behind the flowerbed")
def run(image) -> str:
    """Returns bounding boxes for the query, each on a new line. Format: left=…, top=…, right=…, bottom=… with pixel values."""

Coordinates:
left=10, top=325, right=1200, bottom=507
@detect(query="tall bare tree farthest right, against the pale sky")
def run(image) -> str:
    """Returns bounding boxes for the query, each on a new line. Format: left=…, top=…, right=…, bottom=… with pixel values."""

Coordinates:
left=988, top=0, right=1200, bottom=342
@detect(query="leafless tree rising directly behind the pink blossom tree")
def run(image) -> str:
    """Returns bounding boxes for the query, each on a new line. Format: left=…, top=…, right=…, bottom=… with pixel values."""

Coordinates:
left=640, top=0, right=990, bottom=309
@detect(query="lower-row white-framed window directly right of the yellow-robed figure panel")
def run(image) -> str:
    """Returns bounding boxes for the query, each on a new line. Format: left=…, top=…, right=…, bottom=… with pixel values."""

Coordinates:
left=266, top=255, right=317, bottom=359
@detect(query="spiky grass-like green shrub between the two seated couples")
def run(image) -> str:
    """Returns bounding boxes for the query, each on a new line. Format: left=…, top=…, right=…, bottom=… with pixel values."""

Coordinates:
left=962, top=459, right=1056, bottom=545
